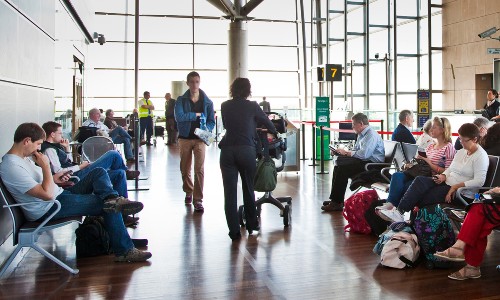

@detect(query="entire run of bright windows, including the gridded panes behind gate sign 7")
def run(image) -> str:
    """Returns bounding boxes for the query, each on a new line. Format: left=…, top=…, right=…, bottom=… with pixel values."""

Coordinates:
left=85, top=0, right=442, bottom=124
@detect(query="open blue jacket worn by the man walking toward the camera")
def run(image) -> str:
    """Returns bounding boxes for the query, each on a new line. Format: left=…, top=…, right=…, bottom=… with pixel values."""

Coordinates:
left=174, top=89, right=215, bottom=137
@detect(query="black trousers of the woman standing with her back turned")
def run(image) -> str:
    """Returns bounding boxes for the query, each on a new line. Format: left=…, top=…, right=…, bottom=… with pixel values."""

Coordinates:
left=219, top=146, right=257, bottom=236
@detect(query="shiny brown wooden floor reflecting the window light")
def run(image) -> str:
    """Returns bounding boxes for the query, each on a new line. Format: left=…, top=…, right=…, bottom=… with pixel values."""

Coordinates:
left=0, top=139, right=500, bottom=299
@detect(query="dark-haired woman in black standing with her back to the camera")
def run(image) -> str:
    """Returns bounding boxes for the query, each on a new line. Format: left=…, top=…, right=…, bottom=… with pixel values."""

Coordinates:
left=219, top=78, right=276, bottom=240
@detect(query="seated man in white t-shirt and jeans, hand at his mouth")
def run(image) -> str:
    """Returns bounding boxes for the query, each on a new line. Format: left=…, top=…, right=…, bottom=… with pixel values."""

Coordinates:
left=0, top=123, right=151, bottom=262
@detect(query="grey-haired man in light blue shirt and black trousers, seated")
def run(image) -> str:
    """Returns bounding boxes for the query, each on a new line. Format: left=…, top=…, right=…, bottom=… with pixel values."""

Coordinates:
left=321, top=113, right=385, bottom=211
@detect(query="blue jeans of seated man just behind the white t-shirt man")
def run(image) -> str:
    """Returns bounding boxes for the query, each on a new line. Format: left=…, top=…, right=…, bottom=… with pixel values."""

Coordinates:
left=74, top=150, right=128, bottom=197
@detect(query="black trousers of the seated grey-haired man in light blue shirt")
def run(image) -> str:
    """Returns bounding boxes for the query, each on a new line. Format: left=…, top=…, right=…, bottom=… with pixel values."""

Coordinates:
left=330, top=159, right=368, bottom=203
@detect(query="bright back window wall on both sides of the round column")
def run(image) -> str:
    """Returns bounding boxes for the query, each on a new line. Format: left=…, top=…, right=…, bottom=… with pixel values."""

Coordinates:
left=85, top=0, right=300, bottom=115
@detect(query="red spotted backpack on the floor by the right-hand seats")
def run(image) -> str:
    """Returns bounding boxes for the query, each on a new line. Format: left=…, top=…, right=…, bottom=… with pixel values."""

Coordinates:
left=342, top=190, right=378, bottom=234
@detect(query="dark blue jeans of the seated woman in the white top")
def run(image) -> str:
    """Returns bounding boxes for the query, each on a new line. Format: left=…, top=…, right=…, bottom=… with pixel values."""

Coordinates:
left=398, top=176, right=451, bottom=212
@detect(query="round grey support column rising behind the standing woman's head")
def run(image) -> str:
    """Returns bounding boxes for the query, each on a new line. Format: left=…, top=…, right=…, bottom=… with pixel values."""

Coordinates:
left=228, top=20, right=248, bottom=85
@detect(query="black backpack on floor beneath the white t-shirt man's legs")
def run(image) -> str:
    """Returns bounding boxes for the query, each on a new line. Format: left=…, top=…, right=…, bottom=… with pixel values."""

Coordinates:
left=75, top=216, right=111, bottom=257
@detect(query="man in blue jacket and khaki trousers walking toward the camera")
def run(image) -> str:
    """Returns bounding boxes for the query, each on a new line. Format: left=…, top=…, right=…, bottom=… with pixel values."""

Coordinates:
left=175, top=71, right=215, bottom=211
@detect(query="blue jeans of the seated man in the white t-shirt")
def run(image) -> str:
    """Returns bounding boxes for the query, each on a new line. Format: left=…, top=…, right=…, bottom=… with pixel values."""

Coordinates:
left=54, top=168, right=134, bottom=256
